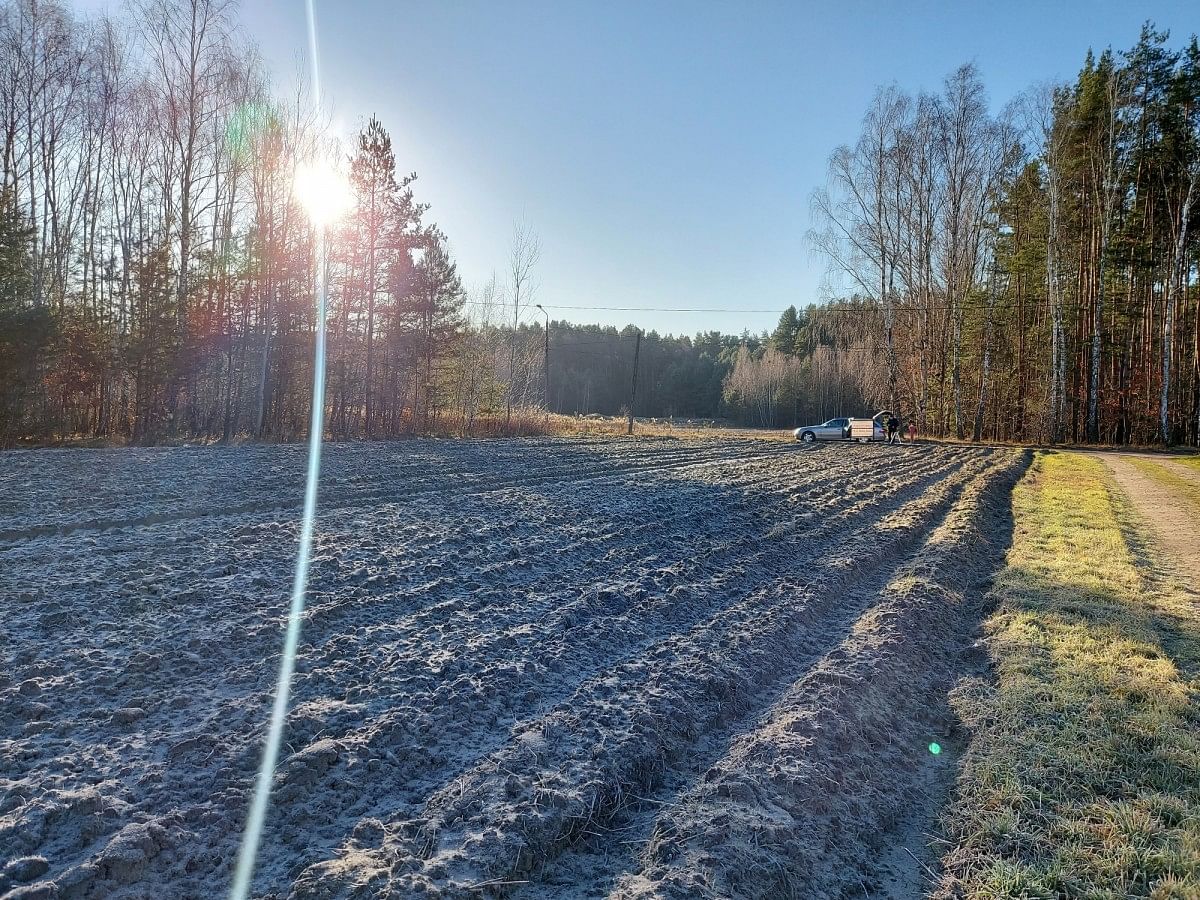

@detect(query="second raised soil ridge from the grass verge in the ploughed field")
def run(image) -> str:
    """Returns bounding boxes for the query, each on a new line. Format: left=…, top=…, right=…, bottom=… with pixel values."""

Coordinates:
left=283, top=457, right=1003, bottom=896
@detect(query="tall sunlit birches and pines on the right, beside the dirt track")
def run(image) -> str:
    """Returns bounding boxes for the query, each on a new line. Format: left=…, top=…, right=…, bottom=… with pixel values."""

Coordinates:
left=811, top=24, right=1200, bottom=444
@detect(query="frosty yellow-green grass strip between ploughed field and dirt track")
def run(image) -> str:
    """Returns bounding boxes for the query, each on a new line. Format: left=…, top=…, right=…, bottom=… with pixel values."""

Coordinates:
left=940, top=452, right=1200, bottom=899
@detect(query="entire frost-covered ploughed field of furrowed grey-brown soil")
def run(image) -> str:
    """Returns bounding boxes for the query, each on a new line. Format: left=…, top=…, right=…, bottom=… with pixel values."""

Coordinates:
left=0, top=440, right=1025, bottom=900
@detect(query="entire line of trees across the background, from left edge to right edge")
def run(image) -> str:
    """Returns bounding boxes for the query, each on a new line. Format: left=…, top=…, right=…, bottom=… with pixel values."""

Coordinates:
left=0, top=0, right=1200, bottom=444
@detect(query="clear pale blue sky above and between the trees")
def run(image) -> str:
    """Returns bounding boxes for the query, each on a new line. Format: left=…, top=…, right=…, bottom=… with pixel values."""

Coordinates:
left=133, top=0, right=1200, bottom=334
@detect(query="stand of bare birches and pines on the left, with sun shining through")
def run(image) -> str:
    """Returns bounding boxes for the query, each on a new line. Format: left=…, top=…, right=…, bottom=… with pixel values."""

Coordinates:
left=0, top=0, right=540, bottom=444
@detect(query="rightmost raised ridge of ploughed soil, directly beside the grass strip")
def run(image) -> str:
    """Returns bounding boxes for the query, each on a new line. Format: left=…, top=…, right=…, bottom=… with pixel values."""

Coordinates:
left=614, top=455, right=1028, bottom=900
